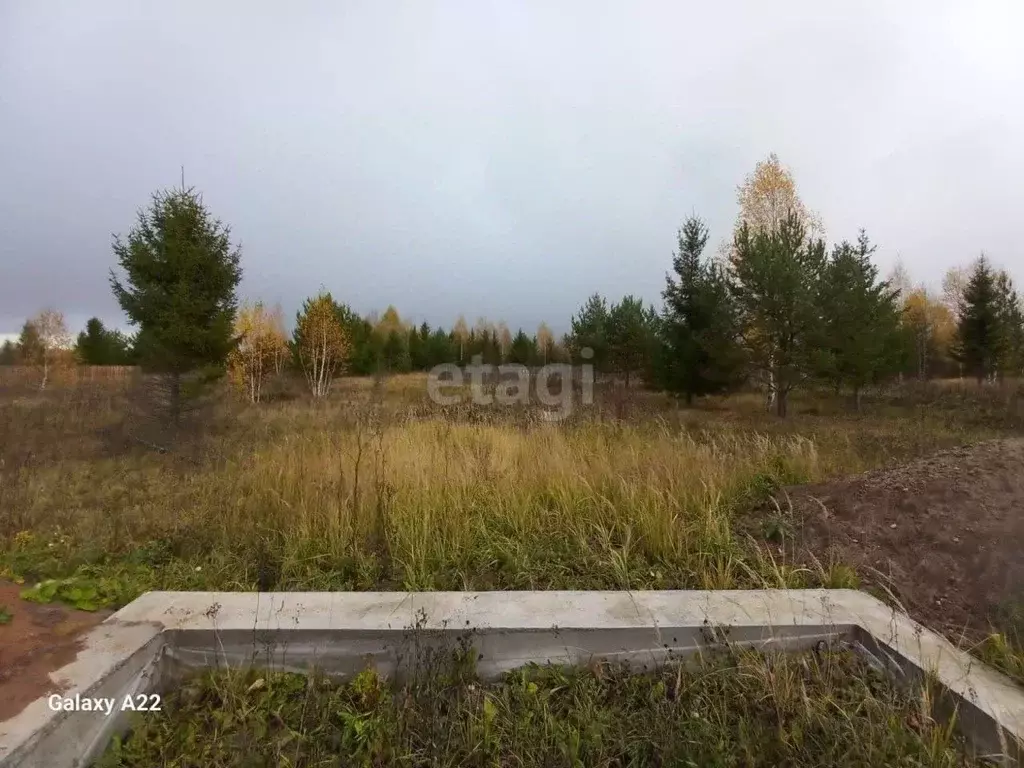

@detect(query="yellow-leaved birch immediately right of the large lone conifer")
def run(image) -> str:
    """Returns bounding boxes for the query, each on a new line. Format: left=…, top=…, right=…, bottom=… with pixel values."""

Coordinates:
left=227, top=301, right=288, bottom=402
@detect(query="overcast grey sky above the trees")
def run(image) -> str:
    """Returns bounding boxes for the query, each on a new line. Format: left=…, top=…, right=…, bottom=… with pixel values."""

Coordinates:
left=0, top=0, right=1024, bottom=332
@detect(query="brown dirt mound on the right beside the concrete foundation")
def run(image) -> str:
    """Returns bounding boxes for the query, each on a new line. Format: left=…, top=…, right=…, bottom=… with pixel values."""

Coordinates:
left=780, top=438, right=1024, bottom=640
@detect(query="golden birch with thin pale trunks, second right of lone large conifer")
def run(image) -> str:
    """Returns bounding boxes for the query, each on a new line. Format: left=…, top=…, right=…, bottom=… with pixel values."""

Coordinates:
left=292, top=292, right=349, bottom=399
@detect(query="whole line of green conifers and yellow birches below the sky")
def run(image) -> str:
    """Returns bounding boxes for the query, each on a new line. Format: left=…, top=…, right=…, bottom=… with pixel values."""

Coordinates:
left=0, top=156, right=1024, bottom=416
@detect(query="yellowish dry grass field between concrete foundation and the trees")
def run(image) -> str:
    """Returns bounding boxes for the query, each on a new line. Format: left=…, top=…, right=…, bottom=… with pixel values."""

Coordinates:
left=0, top=376, right=1018, bottom=607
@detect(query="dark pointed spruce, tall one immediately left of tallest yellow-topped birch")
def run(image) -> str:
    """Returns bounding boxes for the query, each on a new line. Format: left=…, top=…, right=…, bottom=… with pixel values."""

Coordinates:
left=657, top=216, right=742, bottom=404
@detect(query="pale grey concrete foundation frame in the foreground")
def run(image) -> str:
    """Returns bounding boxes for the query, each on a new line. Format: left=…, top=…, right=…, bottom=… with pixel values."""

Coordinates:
left=6, top=590, right=1024, bottom=768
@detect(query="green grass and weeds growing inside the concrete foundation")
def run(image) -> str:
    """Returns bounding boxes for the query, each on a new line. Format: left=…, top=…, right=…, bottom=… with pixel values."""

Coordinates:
left=98, top=650, right=980, bottom=768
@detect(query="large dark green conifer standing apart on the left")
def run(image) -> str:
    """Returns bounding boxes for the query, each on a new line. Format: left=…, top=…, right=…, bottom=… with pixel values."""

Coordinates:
left=111, top=189, right=242, bottom=422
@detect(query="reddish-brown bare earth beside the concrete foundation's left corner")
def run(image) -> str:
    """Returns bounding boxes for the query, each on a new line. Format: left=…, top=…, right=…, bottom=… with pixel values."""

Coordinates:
left=0, top=582, right=111, bottom=722
